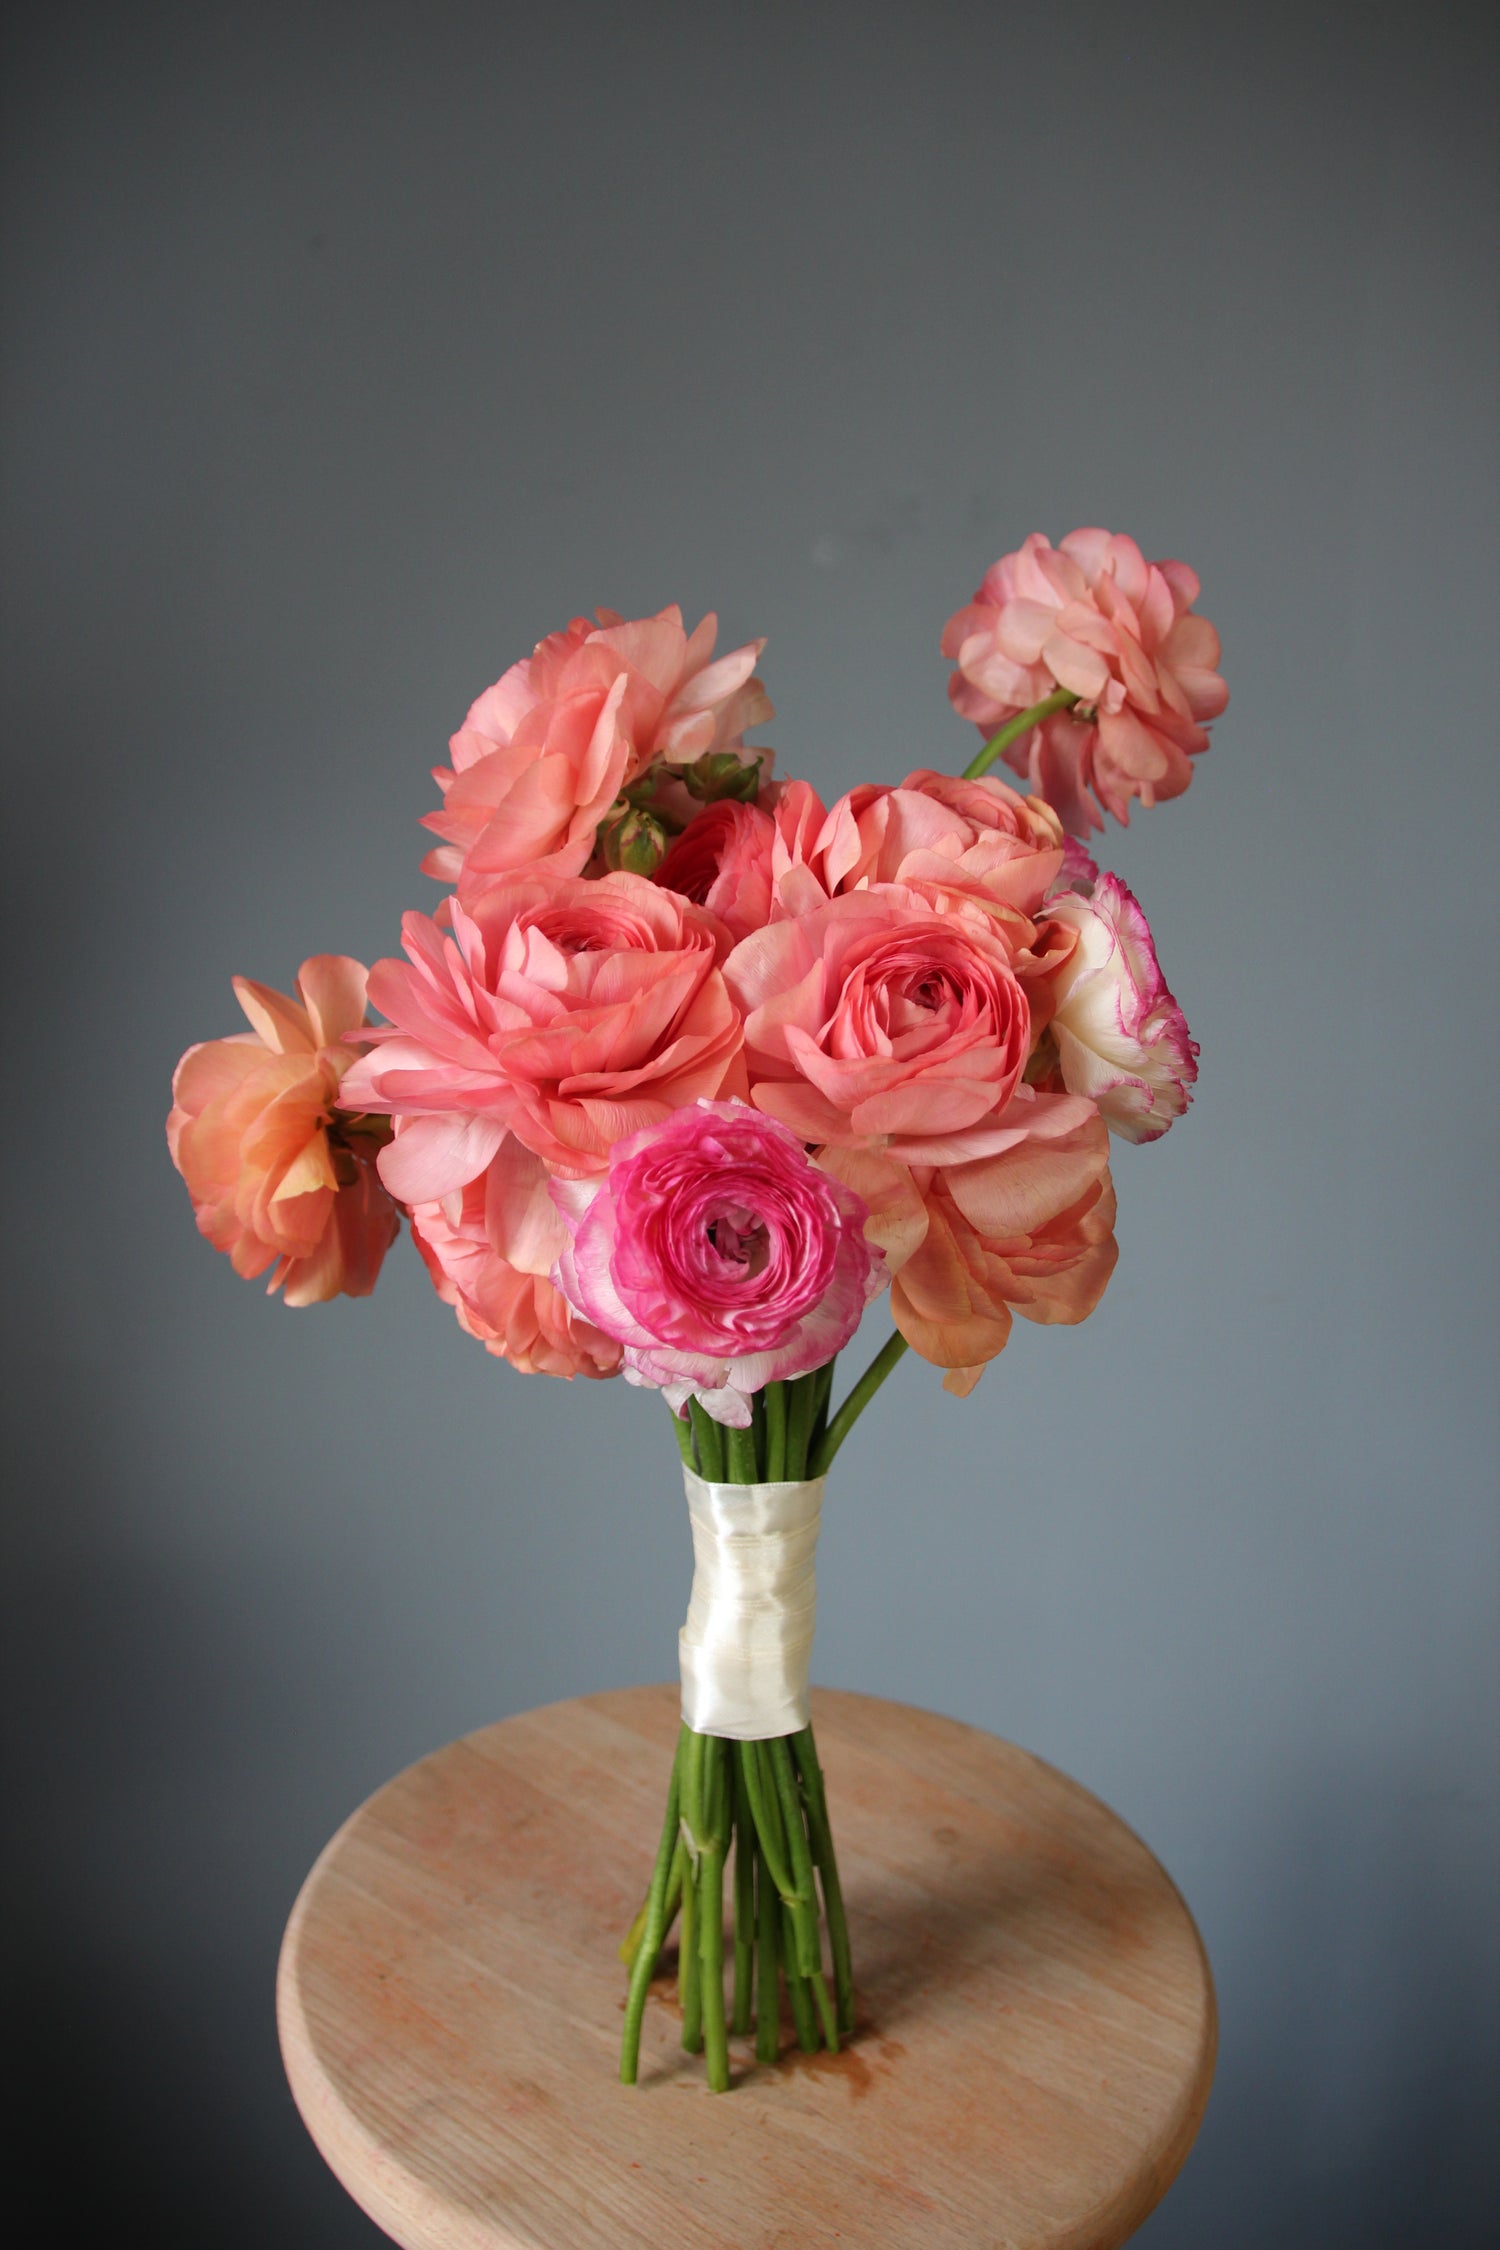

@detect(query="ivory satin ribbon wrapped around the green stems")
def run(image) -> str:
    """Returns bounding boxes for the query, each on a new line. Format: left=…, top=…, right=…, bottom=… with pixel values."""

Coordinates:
left=677, top=1467, right=823, bottom=1742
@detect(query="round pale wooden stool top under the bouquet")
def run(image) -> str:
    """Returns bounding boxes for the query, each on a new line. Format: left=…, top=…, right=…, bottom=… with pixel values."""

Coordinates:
left=277, top=1688, right=1214, bottom=2250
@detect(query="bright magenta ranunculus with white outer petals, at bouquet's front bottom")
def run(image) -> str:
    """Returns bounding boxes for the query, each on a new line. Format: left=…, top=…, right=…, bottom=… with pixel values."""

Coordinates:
left=551, top=1100, right=884, bottom=1429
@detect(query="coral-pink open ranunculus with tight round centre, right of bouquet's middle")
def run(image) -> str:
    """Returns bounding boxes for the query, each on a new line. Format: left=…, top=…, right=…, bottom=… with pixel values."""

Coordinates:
left=724, top=884, right=1032, bottom=1163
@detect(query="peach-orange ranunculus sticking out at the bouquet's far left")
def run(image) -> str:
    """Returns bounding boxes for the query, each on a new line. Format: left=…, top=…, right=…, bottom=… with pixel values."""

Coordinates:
left=166, top=954, right=400, bottom=1305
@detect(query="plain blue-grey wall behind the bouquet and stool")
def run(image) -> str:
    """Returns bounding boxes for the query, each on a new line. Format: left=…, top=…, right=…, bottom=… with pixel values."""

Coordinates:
left=4, top=5, right=1500, bottom=2250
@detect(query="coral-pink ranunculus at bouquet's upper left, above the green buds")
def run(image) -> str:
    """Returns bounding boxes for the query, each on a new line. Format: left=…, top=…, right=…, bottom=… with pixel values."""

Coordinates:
left=423, top=605, right=771, bottom=900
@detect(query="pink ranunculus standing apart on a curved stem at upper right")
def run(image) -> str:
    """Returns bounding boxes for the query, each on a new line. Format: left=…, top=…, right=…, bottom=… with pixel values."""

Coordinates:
left=942, top=529, right=1228, bottom=835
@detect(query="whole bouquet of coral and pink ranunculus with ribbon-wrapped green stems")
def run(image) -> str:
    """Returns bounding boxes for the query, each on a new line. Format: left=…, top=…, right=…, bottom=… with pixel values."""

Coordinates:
left=166, top=531, right=1226, bottom=2088
